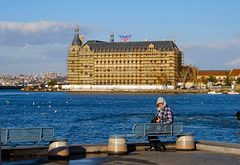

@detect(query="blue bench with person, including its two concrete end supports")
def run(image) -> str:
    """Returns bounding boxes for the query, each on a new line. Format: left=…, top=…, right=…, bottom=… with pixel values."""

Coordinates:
left=108, top=122, right=195, bottom=153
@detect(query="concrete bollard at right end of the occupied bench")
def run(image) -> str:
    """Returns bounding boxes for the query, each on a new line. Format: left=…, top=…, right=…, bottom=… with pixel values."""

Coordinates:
left=176, top=133, right=195, bottom=151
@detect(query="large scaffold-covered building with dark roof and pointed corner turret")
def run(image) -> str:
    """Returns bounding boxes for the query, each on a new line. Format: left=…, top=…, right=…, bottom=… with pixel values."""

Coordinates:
left=67, top=28, right=182, bottom=85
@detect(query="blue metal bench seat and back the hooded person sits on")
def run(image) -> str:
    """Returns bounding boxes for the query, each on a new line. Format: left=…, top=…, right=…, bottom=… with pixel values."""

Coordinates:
left=123, top=122, right=185, bottom=139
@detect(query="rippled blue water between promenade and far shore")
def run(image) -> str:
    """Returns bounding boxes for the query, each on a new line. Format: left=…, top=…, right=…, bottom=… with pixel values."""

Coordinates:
left=0, top=90, right=240, bottom=144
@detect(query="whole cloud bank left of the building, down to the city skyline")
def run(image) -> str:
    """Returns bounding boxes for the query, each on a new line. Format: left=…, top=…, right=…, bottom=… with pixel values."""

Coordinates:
left=0, top=21, right=103, bottom=75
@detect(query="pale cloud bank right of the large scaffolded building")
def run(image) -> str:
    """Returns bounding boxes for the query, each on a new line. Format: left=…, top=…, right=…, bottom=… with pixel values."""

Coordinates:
left=178, top=38, right=240, bottom=70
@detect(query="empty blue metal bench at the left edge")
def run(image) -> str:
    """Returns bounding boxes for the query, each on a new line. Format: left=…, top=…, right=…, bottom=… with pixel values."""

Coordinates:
left=1, top=127, right=54, bottom=145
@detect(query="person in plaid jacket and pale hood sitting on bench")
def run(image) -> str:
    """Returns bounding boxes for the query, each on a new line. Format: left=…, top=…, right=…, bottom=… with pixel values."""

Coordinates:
left=146, top=97, right=173, bottom=151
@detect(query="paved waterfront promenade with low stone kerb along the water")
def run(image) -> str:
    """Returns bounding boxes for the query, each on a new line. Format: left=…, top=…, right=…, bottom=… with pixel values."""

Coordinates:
left=2, top=140, right=240, bottom=165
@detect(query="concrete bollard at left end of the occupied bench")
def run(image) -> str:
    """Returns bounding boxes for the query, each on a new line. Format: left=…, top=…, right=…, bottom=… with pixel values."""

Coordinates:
left=108, top=135, right=128, bottom=154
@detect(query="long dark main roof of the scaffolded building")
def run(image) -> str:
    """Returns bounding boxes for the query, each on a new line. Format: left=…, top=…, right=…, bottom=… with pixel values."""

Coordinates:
left=85, top=40, right=177, bottom=51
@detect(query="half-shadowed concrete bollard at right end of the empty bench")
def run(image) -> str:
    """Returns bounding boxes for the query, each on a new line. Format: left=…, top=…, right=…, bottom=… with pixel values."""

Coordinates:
left=48, top=139, right=69, bottom=159
